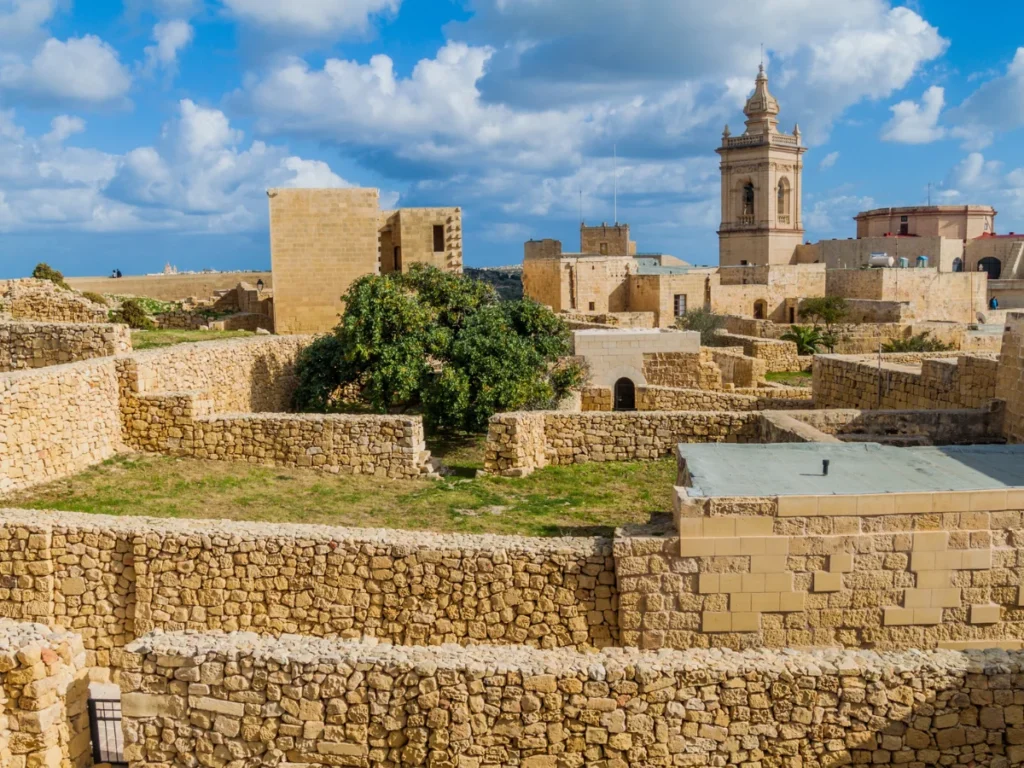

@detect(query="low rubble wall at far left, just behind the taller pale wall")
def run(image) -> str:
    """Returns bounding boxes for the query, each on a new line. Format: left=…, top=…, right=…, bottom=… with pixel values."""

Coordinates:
left=0, top=322, right=131, bottom=373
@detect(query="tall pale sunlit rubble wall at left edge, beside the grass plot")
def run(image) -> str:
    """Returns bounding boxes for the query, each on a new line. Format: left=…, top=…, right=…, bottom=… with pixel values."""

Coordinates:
left=0, top=357, right=122, bottom=494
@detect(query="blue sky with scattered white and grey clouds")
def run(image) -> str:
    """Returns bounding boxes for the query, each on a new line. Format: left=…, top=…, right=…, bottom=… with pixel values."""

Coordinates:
left=0, top=0, right=1024, bottom=278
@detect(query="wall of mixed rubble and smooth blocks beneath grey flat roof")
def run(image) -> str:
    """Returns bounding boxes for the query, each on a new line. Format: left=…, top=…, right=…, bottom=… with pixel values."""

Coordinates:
left=615, top=483, right=1024, bottom=649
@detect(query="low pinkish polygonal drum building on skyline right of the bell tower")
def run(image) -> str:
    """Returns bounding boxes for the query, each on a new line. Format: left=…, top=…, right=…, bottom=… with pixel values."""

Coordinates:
left=854, top=206, right=995, bottom=242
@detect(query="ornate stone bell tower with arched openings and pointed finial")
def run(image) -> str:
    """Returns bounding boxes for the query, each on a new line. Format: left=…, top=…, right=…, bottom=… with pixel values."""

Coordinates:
left=715, top=65, right=807, bottom=266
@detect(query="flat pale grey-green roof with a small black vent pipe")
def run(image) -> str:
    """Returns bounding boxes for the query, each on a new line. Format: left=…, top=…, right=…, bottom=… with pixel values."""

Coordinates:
left=679, top=442, right=1024, bottom=497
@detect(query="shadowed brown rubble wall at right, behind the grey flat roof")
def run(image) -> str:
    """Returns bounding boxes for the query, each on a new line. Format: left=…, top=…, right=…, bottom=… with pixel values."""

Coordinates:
left=813, top=353, right=998, bottom=410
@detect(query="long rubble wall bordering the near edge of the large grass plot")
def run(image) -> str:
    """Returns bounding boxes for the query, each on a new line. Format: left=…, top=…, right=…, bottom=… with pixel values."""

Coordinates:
left=0, top=510, right=618, bottom=667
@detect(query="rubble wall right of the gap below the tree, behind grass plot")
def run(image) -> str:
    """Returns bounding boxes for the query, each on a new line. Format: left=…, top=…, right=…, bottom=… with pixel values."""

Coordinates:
left=483, top=411, right=760, bottom=475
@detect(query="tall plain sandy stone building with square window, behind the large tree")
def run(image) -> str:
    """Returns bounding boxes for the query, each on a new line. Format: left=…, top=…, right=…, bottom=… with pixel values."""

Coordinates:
left=267, top=188, right=462, bottom=334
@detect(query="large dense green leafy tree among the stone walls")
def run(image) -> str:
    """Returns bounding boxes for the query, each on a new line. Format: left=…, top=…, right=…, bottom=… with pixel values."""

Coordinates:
left=295, top=265, right=583, bottom=431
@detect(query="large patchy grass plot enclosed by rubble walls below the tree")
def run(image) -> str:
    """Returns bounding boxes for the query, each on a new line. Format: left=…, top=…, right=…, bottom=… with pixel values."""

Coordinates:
left=4, top=437, right=676, bottom=537
